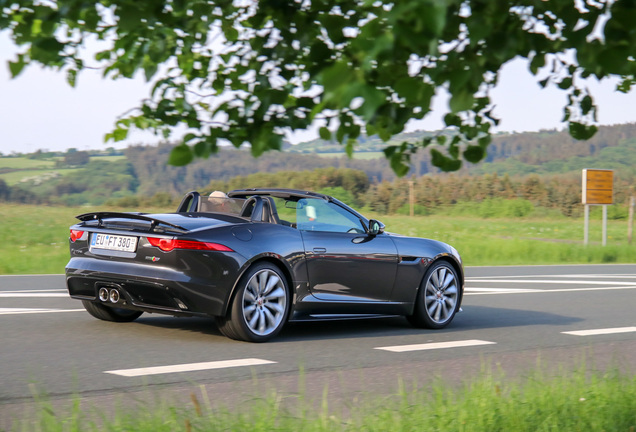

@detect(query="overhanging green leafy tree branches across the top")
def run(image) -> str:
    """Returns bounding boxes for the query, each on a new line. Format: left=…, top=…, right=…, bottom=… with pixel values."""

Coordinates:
left=0, top=0, right=636, bottom=175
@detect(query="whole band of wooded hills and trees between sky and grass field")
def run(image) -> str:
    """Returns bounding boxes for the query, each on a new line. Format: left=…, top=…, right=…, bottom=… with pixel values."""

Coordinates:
left=0, top=124, right=636, bottom=216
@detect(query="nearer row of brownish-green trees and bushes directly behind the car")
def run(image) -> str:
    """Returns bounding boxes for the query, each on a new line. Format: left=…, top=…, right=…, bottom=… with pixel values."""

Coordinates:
left=102, top=168, right=632, bottom=219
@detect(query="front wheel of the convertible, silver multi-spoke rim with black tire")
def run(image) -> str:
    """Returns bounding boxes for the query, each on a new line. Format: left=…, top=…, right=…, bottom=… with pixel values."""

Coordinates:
left=406, top=261, right=462, bottom=329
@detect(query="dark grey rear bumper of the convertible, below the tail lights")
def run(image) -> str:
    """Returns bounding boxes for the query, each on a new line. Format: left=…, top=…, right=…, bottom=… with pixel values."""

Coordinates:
left=66, top=257, right=240, bottom=316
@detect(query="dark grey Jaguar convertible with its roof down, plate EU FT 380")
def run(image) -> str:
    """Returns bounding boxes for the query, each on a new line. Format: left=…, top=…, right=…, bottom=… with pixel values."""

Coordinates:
left=66, top=189, right=464, bottom=342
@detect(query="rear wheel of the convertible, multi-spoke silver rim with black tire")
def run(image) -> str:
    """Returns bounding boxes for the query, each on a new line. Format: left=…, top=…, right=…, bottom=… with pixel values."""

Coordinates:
left=217, top=262, right=290, bottom=342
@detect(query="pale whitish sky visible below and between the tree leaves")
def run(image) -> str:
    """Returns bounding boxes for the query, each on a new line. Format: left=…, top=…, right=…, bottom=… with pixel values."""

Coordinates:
left=0, top=32, right=636, bottom=155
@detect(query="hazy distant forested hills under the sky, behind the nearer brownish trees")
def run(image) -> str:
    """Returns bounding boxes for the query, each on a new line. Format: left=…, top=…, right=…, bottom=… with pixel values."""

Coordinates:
left=0, top=124, right=636, bottom=204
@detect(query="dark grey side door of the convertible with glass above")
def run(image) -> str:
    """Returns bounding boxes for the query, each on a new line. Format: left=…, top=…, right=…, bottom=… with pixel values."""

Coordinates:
left=296, top=198, right=398, bottom=302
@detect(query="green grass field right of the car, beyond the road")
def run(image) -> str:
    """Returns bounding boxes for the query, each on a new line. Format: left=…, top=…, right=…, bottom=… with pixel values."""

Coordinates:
left=372, top=215, right=636, bottom=266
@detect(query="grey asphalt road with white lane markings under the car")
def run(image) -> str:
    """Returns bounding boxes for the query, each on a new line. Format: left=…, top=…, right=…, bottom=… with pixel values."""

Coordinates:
left=0, top=265, right=636, bottom=429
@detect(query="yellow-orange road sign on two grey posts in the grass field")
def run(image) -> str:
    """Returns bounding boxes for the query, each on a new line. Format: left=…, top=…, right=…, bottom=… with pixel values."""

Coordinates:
left=581, top=169, right=614, bottom=246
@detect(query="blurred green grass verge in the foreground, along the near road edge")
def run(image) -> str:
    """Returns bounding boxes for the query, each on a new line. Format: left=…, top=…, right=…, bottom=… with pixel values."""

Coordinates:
left=10, top=367, right=636, bottom=432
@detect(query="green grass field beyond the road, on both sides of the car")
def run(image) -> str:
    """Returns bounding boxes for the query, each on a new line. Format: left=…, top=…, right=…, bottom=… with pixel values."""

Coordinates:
left=0, top=204, right=636, bottom=274
